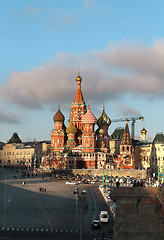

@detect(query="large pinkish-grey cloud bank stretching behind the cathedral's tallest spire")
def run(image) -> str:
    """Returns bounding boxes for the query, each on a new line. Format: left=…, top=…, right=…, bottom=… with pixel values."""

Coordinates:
left=0, top=41, right=164, bottom=108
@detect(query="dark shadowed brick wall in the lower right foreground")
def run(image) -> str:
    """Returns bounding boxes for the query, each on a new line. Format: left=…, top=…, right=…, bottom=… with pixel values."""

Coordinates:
left=111, top=187, right=164, bottom=240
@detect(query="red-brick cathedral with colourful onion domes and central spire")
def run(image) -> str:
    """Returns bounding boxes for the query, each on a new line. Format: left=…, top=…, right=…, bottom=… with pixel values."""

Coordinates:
left=51, top=74, right=134, bottom=169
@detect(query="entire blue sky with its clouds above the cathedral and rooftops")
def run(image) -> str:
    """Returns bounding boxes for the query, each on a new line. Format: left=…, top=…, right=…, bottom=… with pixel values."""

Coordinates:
left=0, top=0, right=164, bottom=142
